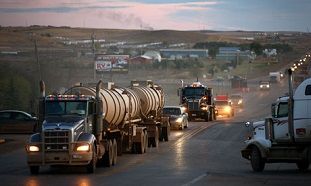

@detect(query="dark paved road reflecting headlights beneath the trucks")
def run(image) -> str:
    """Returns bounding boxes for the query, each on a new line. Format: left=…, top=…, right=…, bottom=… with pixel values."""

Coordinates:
left=0, top=80, right=311, bottom=186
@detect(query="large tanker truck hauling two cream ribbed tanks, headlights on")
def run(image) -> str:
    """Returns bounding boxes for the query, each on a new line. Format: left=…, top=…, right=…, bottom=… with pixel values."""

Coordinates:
left=26, top=81, right=169, bottom=174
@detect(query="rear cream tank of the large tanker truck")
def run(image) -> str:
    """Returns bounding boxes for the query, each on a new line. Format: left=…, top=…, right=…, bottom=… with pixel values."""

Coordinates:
left=131, top=84, right=164, bottom=117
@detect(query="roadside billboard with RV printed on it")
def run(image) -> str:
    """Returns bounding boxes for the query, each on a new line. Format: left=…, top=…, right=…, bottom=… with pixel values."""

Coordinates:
left=95, top=54, right=130, bottom=73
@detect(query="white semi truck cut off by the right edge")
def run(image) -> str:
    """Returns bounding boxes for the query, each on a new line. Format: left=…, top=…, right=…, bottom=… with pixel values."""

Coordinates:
left=241, top=69, right=311, bottom=172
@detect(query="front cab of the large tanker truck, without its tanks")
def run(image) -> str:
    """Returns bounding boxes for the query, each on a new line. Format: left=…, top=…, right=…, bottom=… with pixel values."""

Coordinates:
left=26, top=95, right=100, bottom=174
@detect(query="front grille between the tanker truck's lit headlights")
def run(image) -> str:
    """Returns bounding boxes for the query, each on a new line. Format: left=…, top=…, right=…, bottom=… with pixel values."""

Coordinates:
left=44, top=130, right=70, bottom=151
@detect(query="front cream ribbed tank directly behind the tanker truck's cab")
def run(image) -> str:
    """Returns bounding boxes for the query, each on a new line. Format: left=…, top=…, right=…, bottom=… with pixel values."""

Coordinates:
left=64, top=86, right=140, bottom=128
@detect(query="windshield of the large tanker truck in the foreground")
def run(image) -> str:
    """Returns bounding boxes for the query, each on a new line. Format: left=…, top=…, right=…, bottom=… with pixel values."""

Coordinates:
left=45, top=100, right=87, bottom=115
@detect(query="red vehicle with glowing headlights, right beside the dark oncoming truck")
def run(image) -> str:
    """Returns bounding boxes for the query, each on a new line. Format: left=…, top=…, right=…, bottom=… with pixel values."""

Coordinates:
left=215, top=95, right=234, bottom=117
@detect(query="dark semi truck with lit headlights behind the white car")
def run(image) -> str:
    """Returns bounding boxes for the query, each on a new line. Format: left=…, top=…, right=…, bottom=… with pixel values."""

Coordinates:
left=178, top=81, right=216, bottom=121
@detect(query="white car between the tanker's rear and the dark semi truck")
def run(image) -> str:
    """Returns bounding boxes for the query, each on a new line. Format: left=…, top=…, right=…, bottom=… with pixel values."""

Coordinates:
left=163, top=106, right=188, bottom=130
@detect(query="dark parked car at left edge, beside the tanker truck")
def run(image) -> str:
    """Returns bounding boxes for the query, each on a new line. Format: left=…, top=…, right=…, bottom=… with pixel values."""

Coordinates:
left=0, top=110, right=38, bottom=134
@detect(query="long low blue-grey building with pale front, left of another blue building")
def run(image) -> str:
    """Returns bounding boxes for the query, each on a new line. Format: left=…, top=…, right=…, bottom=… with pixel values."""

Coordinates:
left=160, top=49, right=208, bottom=59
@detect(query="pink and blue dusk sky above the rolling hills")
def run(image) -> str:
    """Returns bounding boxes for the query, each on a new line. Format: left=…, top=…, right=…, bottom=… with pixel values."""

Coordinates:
left=0, top=0, right=311, bottom=32
